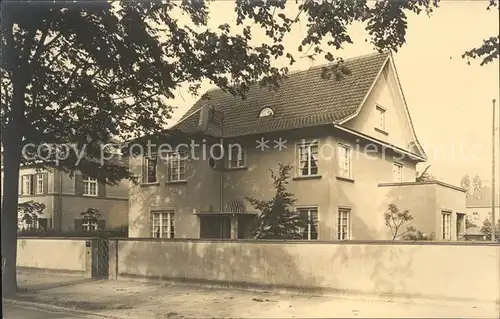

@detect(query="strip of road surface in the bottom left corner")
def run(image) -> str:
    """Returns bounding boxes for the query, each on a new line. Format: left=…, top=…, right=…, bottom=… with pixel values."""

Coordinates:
left=3, top=304, right=101, bottom=319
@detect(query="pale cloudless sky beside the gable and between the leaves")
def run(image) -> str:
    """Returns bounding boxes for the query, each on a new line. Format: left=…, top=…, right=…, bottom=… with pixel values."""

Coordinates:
left=166, top=0, right=500, bottom=187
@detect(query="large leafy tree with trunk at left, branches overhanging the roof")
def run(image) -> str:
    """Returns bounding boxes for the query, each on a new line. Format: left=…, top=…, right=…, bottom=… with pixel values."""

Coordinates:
left=0, top=0, right=496, bottom=296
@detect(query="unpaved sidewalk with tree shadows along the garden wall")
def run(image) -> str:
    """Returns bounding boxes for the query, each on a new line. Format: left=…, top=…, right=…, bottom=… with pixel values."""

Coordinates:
left=8, top=273, right=500, bottom=319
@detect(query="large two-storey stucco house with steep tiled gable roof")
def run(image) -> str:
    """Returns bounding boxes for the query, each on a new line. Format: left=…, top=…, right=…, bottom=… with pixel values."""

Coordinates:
left=129, top=53, right=465, bottom=240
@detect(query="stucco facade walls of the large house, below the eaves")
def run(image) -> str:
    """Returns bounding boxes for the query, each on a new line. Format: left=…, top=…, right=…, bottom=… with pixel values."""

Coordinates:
left=129, top=127, right=415, bottom=240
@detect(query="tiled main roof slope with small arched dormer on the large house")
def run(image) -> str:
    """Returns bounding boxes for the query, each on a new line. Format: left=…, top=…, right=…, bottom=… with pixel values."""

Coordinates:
left=173, top=53, right=390, bottom=137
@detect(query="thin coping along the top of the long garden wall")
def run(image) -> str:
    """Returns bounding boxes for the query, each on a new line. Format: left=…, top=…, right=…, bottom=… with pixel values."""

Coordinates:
left=109, top=237, right=500, bottom=246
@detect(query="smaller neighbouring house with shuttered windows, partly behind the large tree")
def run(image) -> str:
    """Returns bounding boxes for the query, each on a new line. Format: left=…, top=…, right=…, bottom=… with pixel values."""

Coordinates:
left=2, top=167, right=129, bottom=231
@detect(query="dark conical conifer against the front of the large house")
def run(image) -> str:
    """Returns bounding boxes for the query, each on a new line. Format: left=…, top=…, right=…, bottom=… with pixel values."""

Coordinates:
left=247, top=163, right=304, bottom=239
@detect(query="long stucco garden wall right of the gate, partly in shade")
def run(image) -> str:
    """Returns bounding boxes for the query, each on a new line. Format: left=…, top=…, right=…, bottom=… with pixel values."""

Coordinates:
left=110, top=239, right=500, bottom=302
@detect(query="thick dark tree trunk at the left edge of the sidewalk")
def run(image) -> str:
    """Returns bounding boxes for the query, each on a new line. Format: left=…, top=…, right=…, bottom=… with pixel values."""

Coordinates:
left=1, top=123, right=21, bottom=297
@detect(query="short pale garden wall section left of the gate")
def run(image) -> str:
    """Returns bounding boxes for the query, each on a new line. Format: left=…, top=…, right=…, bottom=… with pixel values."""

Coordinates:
left=17, top=238, right=89, bottom=273
